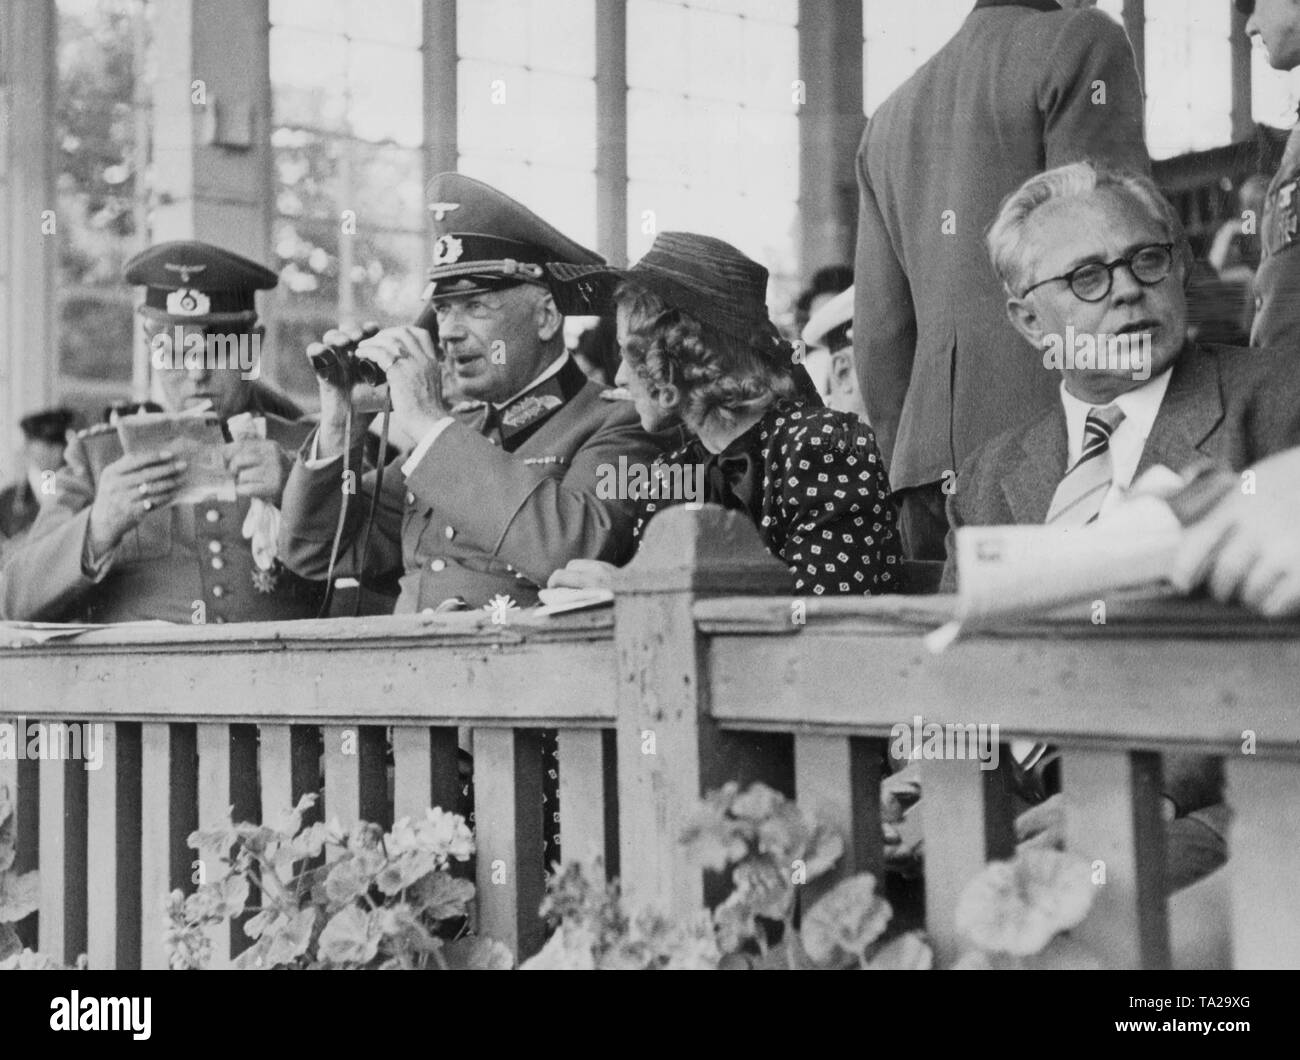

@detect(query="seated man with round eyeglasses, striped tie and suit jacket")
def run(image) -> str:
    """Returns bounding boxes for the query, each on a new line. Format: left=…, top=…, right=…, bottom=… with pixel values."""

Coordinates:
left=944, top=163, right=1300, bottom=888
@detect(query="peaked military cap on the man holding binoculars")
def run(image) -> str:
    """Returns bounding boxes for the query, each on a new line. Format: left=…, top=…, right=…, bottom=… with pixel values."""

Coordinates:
left=425, top=173, right=605, bottom=298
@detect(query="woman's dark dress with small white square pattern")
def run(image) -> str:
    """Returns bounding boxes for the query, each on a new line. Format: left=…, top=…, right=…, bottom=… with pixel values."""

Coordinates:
left=633, top=398, right=902, bottom=596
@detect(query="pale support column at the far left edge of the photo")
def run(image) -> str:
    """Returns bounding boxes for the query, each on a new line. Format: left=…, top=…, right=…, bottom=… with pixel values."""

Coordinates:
left=0, top=0, right=61, bottom=463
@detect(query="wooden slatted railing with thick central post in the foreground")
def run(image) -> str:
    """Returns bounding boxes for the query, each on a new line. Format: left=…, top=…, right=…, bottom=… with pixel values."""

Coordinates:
left=0, top=509, right=1300, bottom=968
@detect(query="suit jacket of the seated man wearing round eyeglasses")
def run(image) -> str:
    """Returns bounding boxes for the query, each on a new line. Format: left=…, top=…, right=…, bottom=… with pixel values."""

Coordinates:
left=943, top=346, right=1300, bottom=812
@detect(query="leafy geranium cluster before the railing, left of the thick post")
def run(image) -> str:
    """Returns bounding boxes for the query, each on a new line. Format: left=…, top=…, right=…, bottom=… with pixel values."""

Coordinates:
left=166, top=795, right=514, bottom=969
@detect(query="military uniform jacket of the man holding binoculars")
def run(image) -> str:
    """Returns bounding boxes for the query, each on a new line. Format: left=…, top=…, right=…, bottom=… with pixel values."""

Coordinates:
left=280, top=359, right=663, bottom=614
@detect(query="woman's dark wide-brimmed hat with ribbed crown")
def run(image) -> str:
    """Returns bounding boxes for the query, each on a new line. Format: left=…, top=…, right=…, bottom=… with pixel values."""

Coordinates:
left=546, top=232, right=776, bottom=342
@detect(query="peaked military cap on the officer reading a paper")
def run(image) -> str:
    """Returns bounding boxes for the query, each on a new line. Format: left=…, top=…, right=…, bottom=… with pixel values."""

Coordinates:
left=125, top=239, right=278, bottom=324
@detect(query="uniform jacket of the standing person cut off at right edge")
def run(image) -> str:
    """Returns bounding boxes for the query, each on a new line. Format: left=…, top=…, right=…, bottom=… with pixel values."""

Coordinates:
left=1251, top=126, right=1300, bottom=354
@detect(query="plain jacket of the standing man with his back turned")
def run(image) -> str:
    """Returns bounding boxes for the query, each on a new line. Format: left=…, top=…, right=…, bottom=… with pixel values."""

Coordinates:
left=853, top=0, right=1151, bottom=490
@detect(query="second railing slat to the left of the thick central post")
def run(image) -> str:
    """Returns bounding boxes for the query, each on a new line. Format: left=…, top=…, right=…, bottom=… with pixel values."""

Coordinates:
left=473, top=728, right=543, bottom=960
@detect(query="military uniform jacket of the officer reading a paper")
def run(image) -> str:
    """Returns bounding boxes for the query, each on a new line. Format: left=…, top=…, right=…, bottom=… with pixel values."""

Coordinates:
left=0, top=388, right=324, bottom=623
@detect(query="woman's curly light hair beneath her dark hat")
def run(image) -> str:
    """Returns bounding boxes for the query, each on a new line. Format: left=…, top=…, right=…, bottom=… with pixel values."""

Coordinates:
left=614, top=282, right=797, bottom=424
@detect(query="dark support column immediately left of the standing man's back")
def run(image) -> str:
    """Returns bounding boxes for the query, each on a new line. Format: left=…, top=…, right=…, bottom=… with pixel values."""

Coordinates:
left=800, top=0, right=866, bottom=276
